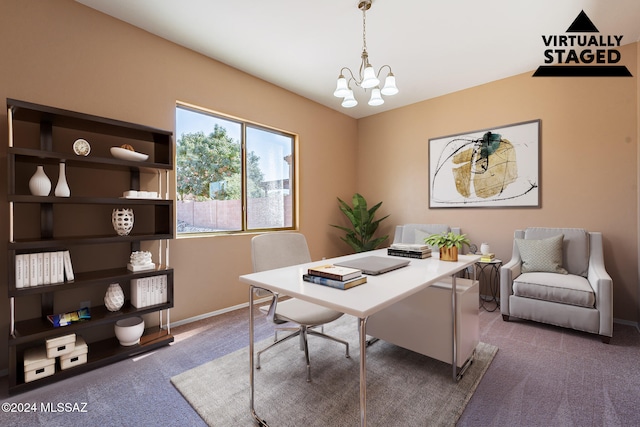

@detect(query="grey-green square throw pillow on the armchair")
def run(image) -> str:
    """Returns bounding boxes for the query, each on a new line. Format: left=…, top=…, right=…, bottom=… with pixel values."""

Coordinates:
left=515, top=234, right=568, bottom=274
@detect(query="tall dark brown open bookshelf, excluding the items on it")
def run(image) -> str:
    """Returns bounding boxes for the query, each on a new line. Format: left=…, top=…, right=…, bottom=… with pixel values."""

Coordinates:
left=7, top=99, right=175, bottom=394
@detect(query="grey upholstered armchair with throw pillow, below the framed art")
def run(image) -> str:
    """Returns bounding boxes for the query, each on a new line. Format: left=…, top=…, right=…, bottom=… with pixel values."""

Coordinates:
left=500, top=227, right=613, bottom=343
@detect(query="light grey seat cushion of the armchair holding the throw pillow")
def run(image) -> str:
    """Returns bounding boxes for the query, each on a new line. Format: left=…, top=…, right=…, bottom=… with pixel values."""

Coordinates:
left=513, top=272, right=595, bottom=308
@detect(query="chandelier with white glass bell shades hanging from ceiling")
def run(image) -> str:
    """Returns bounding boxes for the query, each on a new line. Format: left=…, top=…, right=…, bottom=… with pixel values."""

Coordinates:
left=333, top=0, right=398, bottom=108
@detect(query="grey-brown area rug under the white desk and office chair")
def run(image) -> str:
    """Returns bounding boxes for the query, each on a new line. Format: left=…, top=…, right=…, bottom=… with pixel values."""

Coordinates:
left=171, top=316, right=498, bottom=427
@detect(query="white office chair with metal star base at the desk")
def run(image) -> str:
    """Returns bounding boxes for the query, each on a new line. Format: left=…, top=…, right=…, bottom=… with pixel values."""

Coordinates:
left=251, top=233, right=349, bottom=381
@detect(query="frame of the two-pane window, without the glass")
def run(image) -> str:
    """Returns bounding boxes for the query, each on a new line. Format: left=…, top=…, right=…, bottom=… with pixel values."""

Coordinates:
left=173, top=101, right=299, bottom=238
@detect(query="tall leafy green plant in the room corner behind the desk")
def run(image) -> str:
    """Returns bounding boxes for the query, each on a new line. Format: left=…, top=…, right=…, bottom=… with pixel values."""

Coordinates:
left=331, top=193, right=389, bottom=252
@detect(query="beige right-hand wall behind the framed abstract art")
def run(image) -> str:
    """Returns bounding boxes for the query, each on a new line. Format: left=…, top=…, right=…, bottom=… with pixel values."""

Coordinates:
left=358, top=43, right=639, bottom=322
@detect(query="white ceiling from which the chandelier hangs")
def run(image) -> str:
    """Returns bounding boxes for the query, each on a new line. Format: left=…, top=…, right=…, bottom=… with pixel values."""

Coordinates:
left=76, top=0, right=640, bottom=118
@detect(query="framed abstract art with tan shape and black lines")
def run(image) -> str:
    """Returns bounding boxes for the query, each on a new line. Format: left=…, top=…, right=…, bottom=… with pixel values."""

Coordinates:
left=429, top=119, right=541, bottom=208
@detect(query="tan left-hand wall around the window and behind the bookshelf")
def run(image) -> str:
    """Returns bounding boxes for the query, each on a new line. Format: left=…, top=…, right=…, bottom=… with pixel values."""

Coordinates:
left=0, top=0, right=357, bottom=369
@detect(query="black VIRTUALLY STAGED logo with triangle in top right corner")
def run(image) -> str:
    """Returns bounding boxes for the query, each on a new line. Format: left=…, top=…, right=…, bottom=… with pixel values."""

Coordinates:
left=533, top=11, right=631, bottom=77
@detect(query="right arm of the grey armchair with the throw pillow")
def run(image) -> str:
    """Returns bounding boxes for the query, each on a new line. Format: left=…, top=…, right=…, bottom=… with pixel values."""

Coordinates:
left=587, top=232, right=613, bottom=337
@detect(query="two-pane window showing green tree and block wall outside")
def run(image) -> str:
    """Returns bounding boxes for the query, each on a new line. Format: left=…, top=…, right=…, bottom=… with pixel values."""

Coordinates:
left=176, top=104, right=296, bottom=235
